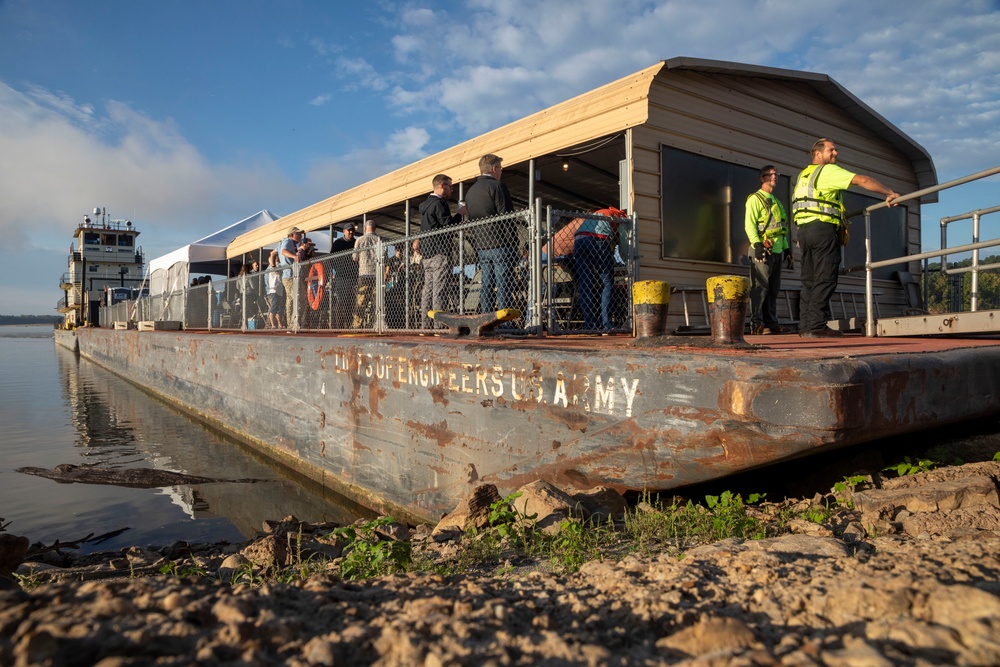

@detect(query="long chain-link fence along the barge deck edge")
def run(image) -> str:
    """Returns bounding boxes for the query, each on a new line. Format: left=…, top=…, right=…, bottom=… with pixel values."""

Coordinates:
left=102, top=202, right=638, bottom=335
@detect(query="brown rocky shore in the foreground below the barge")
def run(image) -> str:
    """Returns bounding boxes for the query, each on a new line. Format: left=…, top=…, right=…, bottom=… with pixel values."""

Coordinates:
left=0, top=461, right=1000, bottom=667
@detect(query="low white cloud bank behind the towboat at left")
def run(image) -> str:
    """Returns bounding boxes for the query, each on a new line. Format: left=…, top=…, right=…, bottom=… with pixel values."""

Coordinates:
left=0, top=82, right=302, bottom=313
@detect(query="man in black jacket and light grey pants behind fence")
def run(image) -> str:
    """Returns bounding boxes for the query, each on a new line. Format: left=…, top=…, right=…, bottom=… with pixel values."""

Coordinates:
left=420, top=174, right=465, bottom=329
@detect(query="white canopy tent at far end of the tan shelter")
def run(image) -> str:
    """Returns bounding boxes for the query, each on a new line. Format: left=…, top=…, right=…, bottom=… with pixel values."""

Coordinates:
left=149, top=209, right=286, bottom=295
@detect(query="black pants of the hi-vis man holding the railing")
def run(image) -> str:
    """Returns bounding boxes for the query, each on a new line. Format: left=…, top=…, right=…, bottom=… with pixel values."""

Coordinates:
left=798, top=220, right=840, bottom=331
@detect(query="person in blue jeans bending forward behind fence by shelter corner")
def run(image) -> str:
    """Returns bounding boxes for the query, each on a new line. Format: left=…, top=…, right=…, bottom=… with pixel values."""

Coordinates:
left=573, top=208, right=628, bottom=332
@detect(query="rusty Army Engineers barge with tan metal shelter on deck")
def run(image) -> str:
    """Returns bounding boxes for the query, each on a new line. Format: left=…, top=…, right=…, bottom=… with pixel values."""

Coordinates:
left=56, top=58, right=1000, bottom=521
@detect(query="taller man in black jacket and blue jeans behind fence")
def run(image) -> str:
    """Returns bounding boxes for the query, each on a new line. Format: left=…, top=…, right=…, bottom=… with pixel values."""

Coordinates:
left=465, top=154, right=518, bottom=313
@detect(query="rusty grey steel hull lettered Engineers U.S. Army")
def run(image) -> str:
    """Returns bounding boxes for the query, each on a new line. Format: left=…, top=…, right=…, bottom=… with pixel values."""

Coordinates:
left=66, top=329, right=1000, bottom=520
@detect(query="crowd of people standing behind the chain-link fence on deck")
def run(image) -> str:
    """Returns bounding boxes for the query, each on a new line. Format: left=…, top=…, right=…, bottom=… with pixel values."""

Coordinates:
left=199, top=154, right=626, bottom=333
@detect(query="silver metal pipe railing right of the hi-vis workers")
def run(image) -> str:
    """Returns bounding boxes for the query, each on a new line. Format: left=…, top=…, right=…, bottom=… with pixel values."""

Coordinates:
left=864, top=166, right=1000, bottom=337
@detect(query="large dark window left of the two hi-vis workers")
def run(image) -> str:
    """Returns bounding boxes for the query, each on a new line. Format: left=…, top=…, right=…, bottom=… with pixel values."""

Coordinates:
left=660, top=146, right=790, bottom=264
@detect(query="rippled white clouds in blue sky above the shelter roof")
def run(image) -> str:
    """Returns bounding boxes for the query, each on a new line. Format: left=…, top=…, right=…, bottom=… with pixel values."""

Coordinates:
left=376, top=0, right=1000, bottom=177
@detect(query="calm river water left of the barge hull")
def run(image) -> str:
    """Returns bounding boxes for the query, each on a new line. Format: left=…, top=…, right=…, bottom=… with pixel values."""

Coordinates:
left=0, top=325, right=370, bottom=553
